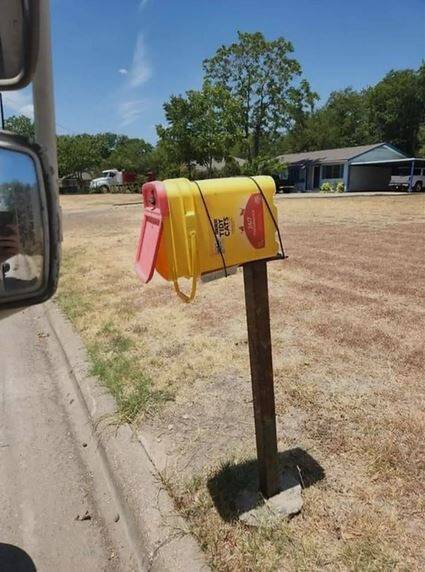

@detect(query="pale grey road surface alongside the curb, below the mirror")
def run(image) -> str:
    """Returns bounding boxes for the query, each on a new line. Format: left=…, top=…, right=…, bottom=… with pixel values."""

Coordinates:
left=0, top=307, right=137, bottom=572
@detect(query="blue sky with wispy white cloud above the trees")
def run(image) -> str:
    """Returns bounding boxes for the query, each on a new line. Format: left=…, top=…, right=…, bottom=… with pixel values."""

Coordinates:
left=4, top=0, right=425, bottom=143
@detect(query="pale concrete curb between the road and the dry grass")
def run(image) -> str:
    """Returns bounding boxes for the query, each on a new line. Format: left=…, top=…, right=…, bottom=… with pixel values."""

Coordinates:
left=43, top=301, right=210, bottom=572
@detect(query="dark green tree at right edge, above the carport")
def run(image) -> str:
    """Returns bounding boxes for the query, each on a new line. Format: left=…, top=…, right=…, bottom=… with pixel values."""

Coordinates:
left=368, top=63, right=425, bottom=155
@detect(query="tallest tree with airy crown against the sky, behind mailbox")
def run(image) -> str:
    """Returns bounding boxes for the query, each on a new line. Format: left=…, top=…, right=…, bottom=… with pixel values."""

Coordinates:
left=204, top=32, right=317, bottom=160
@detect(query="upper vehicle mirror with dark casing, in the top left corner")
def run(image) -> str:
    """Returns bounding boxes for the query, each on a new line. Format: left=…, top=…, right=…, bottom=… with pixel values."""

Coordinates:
left=0, top=0, right=39, bottom=91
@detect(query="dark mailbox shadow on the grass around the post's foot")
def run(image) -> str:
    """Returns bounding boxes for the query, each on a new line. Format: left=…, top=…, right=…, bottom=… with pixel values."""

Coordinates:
left=207, top=448, right=325, bottom=521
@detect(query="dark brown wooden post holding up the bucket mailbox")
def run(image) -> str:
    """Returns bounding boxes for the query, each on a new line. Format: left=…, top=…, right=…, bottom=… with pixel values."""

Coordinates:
left=243, top=260, right=280, bottom=498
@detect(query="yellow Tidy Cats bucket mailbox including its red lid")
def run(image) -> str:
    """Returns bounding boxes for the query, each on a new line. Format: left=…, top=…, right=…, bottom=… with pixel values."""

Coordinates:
left=136, top=176, right=279, bottom=302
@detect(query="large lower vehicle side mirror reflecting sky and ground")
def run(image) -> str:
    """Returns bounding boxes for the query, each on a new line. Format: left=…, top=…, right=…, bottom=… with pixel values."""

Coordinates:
left=0, top=132, right=61, bottom=309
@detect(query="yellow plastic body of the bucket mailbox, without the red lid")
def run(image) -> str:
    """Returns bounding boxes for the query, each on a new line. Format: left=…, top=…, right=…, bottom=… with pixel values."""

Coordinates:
left=156, top=176, right=278, bottom=288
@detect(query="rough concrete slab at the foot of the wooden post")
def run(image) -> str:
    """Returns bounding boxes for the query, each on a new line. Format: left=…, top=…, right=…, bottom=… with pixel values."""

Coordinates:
left=236, top=470, right=303, bottom=528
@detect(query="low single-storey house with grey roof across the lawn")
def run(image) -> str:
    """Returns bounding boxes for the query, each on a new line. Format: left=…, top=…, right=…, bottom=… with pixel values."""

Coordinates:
left=277, top=143, right=415, bottom=191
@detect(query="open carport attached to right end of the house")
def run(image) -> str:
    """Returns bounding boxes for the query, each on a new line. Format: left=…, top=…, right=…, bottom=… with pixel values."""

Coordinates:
left=347, top=157, right=425, bottom=192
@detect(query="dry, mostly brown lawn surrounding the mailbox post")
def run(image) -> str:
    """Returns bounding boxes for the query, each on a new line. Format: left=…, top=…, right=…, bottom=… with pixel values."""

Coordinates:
left=58, top=195, right=425, bottom=571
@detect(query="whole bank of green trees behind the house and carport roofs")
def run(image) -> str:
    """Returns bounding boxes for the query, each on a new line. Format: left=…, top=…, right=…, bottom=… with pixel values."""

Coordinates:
left=273, top=64, right=425, bottom=154
